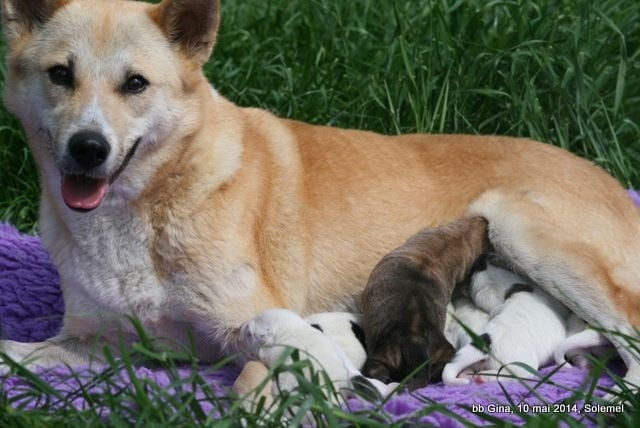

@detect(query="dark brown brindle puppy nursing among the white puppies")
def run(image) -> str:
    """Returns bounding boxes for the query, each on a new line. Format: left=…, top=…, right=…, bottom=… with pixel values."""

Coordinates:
left=362, top=217, right=489, bottom=388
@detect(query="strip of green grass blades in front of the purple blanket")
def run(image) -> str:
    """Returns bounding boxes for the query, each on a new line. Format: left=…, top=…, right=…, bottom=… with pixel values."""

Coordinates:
left=0, top=322, right=640, bottom=428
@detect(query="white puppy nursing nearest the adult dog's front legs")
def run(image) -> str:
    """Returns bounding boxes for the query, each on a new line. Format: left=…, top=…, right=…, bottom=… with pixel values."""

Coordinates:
left=238, top=309, right=392, bottom=396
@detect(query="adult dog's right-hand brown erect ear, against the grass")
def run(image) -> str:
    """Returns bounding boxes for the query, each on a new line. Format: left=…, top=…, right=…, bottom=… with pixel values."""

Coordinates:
left=151, top=0, right=220, bottom=64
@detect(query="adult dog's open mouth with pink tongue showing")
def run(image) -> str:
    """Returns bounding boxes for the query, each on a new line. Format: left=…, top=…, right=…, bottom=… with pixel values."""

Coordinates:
left=60, top=138, right=141, bottom=212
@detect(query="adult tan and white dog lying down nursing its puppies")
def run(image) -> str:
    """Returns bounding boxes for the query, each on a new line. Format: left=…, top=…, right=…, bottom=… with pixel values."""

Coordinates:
left=2, top=0, right=640, bottom=388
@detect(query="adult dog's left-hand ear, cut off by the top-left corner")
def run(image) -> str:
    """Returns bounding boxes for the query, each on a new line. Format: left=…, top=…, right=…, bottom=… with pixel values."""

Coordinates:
left=1, top=0, right=70, bottom=42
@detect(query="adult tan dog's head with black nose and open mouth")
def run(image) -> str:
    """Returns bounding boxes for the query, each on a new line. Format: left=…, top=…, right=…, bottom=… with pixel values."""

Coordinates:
left=1, top=0, right=219, bottom=211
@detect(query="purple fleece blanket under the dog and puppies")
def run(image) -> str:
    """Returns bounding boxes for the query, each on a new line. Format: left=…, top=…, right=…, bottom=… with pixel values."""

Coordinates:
left=0, top=191, right=640, bottom=426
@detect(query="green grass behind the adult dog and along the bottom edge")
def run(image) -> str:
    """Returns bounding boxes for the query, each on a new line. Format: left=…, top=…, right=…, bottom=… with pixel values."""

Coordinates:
left=0, top=0, right=640, bottom=427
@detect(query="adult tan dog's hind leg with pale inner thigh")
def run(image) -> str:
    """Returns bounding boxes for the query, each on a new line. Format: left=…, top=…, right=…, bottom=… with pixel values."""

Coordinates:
left=469, top=188, right=640, bottom=396
